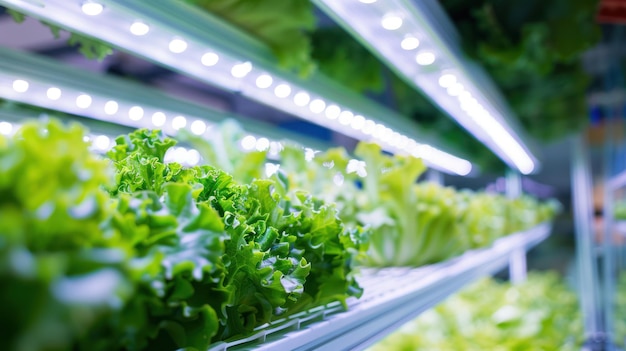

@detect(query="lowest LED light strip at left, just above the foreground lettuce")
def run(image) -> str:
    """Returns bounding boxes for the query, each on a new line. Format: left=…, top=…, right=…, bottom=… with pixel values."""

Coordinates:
left=0, top=48, right=328, bottom=155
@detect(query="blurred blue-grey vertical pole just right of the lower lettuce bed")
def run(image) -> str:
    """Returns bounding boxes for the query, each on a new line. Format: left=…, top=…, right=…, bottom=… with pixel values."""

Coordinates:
left=571, top=134, right=601, bottom=338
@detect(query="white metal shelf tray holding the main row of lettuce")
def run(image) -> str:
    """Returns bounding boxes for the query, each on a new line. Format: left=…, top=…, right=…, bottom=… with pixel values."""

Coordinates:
left=209, top=223, right=551, bottom=351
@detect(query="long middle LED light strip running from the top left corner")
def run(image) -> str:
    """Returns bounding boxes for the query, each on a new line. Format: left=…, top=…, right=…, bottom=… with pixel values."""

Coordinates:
left=0, top=0, right=471, bottom=175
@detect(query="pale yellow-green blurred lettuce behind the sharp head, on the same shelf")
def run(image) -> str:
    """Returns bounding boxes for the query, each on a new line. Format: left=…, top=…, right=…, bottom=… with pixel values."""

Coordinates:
left=181, top=121, right=560, bottom=267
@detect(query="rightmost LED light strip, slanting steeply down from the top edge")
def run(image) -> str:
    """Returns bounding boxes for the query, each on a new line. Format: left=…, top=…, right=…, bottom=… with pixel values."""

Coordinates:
left=313, top=0, right=538, bottom=174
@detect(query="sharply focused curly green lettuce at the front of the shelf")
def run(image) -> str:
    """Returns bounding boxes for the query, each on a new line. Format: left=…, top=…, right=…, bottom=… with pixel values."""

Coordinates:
left=109, top=130, right=361, bottom=346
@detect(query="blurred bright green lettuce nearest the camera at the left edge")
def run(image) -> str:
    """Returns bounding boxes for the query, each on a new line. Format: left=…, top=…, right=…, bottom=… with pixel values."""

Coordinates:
left=0, top=121, right=134, bottom=350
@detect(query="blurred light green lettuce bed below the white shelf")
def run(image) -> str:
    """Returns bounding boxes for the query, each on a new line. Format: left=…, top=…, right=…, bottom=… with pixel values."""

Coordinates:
left=369, top=272, right=584, bottom=351
